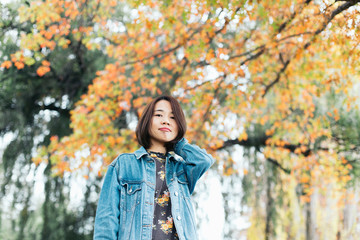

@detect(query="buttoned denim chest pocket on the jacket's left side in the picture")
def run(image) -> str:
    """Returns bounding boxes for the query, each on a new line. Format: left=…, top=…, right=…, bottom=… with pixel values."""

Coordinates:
left=120, top=180, right=142, bottom=212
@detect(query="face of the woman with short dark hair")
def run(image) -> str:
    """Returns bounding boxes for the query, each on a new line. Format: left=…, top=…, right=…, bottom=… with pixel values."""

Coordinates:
left=149, top=100, right=178, bottom=147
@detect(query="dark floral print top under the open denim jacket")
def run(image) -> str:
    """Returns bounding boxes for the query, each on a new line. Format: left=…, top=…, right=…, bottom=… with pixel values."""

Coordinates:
left=149, top=151, right=179, bottom=240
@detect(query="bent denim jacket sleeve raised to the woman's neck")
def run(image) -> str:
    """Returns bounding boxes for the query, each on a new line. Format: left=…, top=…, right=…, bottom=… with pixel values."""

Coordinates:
left=174, top=138, right=215, bottom=194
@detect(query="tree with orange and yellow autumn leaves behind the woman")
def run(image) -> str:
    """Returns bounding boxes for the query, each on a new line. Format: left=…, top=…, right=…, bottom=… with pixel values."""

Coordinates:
left=2, top=0, right=359, bottom=239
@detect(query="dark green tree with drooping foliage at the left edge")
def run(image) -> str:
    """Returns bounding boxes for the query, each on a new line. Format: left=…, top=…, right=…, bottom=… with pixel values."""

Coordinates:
left=0, top=2, right=110, bottom=239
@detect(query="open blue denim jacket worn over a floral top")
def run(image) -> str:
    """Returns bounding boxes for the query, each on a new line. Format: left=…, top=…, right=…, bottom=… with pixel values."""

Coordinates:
left=94, top=138, right=214, bottom=240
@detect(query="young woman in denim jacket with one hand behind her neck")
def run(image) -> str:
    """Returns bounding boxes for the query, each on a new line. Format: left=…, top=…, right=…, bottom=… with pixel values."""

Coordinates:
left=94, top=96, right=214, bottom=240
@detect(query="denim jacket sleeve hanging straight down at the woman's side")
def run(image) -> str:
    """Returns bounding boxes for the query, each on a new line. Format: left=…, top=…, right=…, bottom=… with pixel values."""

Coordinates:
left=94, top=164, right=121, bottom=240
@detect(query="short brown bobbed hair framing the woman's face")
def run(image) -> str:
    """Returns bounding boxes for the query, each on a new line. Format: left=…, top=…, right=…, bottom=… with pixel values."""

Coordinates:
left=136, top=95, right=186, bottom=151
